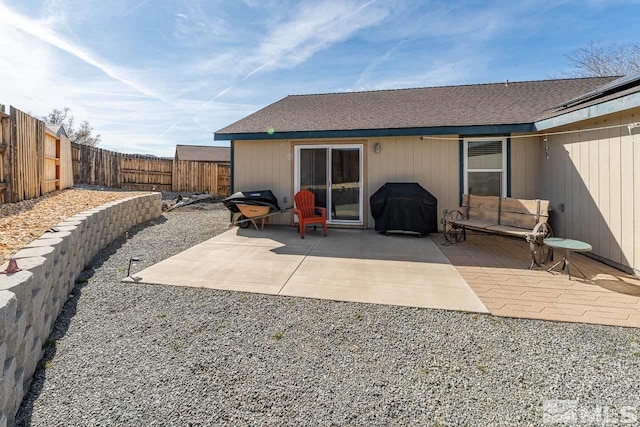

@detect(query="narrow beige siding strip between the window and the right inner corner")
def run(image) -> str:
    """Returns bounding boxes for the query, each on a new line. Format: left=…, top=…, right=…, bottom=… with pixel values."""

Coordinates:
left=511, top=134, right=544, bottom=199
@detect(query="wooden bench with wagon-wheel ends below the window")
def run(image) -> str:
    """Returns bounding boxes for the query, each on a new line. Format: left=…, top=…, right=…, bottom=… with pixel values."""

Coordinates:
left=443, top=194, right=552, bottom=268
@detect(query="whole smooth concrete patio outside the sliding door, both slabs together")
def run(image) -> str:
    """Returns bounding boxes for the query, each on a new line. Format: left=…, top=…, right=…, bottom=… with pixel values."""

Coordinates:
left=130, top=227, right=489, bottom=313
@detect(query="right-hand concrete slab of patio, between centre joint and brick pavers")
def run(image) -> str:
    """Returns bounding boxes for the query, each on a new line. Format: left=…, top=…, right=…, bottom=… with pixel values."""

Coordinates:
left=280, top=230, right=487, bottom=312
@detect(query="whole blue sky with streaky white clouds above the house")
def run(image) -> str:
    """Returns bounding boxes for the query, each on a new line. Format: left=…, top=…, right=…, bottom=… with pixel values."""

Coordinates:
left=0, top=0, right=640, bottom=156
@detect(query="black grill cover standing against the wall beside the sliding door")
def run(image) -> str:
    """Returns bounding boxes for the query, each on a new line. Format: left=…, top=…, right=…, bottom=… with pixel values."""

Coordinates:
left=369, top=182, right=438, bottom=234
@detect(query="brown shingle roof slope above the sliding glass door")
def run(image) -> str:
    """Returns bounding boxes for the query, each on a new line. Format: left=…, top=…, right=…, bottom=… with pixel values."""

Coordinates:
left=216, top=77, right=615, bottom=135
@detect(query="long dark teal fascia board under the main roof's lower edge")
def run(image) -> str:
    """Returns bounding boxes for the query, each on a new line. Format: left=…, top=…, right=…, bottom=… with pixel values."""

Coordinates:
left=214, top=123, right=536, bottom=141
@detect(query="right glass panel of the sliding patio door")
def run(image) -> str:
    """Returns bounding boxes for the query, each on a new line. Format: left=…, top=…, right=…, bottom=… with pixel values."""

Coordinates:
left=331, top=147, right=361, bottom=221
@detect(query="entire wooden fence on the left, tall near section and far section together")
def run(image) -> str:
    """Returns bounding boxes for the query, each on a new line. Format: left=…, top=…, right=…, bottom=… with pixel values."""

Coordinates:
left=0, top=105, right=231, bottom=203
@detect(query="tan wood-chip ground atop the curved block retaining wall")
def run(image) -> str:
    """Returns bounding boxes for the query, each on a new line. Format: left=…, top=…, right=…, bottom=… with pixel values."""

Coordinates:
left=0, top=188, right=141, bottom=264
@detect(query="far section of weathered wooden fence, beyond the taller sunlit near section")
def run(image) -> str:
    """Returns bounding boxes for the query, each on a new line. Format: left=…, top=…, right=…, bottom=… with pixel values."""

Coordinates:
left=71, top=144, right=231, bottom=196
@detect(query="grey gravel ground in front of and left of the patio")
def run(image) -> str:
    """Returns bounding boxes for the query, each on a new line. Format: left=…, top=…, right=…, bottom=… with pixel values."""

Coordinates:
left=13, top=206, right=640, bottom=426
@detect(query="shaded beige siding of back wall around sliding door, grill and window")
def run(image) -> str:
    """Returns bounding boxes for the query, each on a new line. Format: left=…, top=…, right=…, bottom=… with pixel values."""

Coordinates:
left=234, top=135, right=543, bottom=228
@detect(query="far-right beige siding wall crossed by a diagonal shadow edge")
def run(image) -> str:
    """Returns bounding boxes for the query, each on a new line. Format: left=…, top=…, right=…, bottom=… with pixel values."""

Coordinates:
left=542, top=109, right=640, bottom=269
